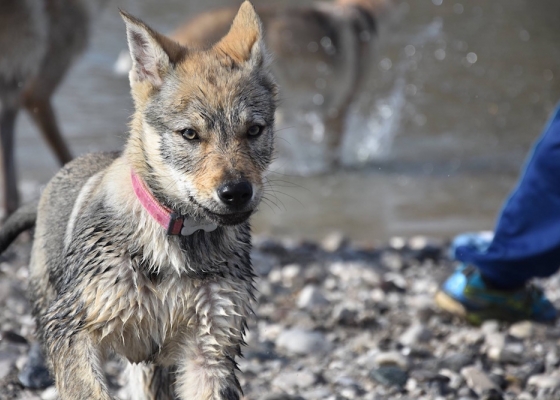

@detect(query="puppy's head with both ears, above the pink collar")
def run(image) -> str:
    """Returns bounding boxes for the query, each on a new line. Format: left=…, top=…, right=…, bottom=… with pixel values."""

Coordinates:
left=122, top=1, right=277, bottom=225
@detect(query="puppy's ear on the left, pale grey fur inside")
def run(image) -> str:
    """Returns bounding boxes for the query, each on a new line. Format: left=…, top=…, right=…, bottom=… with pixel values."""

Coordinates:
left=121, top=10, right=187, bottom=88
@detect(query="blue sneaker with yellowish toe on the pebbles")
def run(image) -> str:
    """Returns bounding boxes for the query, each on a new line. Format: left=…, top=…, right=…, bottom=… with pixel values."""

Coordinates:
left=435, top=264, right=557, bottom=325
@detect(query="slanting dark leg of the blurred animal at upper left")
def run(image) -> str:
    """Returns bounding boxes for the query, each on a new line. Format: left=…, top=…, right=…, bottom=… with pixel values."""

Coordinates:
left=25, top=94, right=72, bottom=165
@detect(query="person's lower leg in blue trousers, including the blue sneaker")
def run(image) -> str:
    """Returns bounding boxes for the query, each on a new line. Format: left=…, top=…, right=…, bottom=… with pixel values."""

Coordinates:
left=436, top=107, right=560, bottom=323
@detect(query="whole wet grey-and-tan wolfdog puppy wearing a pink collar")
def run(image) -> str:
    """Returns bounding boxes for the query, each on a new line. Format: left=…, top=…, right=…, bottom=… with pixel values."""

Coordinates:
left=0, top=1, right=277, bottom=400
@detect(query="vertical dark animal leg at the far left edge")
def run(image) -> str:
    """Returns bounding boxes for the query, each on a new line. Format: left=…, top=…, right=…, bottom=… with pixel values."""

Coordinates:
left=0, top=105, right=19, bottom=216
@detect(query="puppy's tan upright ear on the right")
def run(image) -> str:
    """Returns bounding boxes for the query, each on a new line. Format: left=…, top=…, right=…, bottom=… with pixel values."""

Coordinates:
left=214, top=1, right=266, bottom=65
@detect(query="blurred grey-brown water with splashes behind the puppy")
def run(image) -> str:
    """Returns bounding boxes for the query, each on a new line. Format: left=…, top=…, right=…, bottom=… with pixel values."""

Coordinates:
left=16, top=0, right=560, bottom=241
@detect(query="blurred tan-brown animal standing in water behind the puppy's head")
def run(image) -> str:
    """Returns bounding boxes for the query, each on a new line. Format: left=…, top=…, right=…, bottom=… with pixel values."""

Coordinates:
left=171, top=0, right=388, bottom=164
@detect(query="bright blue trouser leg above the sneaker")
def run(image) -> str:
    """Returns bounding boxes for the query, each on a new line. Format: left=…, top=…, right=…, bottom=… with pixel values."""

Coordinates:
left=455, top=106, right=560, bottom=288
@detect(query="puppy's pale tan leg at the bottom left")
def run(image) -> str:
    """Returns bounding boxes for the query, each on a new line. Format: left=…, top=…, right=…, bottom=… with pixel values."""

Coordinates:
left=46, top=330, right=111, bottom=400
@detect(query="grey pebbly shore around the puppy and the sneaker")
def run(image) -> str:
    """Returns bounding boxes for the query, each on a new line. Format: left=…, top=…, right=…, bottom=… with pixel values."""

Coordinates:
left=0, top=235, right=560, bottom=400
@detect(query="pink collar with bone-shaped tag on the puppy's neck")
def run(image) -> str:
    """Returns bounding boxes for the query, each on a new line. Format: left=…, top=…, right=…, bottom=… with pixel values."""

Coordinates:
left=130, top=169, right=218, bottom=236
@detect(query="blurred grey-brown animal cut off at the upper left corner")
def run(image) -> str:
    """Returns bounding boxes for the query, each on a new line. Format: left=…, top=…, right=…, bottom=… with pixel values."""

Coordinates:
left=0, top=0, right=107, bottom=214
